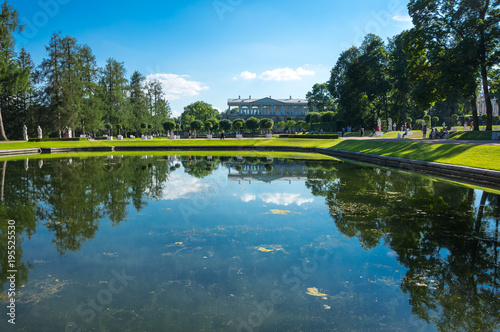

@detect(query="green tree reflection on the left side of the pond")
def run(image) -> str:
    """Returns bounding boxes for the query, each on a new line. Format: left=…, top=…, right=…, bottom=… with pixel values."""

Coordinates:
left=0, top=158, right=176, bottom=294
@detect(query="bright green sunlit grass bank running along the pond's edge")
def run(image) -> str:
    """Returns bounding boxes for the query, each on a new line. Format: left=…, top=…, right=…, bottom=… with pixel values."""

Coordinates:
left=0, top=138, right=500, bottom=171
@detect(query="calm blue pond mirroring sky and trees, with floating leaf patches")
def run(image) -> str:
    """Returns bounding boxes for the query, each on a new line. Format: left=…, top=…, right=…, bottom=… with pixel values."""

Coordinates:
left=0, top=153, right=500, bottom=331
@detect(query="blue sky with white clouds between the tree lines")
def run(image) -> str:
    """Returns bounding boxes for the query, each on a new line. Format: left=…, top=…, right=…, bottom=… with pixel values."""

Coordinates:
left=13, top=0, right=412, bottom=116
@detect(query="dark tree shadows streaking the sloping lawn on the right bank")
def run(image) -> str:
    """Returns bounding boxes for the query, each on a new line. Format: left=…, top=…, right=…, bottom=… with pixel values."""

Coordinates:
left=331, top=141, right=477, bottom=161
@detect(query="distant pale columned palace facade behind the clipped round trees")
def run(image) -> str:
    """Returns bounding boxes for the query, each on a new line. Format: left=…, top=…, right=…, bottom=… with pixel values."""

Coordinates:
left=225, top=96, right=309, bottom=123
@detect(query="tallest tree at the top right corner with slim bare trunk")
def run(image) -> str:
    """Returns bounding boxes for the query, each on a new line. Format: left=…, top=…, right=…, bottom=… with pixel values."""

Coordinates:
left=408, top=0, right=500, bottom=130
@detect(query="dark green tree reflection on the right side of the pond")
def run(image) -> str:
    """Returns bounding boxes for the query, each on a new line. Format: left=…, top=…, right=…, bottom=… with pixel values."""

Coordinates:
left=307, top=164, right=500, bottom=331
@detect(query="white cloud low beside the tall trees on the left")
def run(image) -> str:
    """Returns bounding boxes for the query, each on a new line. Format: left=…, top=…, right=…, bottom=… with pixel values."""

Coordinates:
left=146, top=73, right=209, bottom=100
